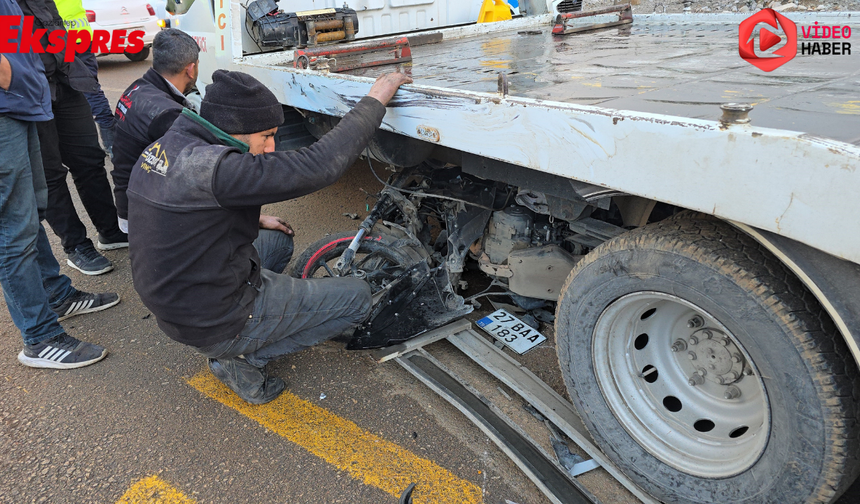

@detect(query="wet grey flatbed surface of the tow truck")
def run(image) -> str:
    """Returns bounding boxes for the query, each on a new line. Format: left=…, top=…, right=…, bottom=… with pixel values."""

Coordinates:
left=351, top=13, right=860, bottom=144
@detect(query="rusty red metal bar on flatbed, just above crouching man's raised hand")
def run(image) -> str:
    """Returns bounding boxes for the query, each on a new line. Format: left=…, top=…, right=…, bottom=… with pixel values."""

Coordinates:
left=293, top=36, right=412, bottom=72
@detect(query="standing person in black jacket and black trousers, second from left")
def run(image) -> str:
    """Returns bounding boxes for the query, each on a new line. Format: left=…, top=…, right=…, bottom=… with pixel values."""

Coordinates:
left=17, top=0, right=128, bottom=275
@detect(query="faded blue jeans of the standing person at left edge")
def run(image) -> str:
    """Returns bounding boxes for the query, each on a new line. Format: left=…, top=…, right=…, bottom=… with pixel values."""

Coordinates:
left=0, top=115, right=75, bottom=345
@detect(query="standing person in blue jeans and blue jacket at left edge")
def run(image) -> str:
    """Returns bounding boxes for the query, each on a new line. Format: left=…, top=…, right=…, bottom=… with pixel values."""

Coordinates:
left=0, top=0, right=119, bottom=369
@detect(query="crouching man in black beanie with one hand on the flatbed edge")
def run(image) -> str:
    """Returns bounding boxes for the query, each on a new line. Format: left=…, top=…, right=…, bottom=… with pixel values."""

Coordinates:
left=127, top=70, right=411, bottom=404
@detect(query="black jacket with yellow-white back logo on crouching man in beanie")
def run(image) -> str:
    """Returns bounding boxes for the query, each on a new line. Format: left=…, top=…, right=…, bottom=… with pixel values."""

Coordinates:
left=127, top=97, right=385, bottom=347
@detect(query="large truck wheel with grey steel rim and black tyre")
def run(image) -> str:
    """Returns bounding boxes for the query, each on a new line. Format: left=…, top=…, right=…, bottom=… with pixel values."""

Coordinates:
left=556, top=217, right=860, bottom=504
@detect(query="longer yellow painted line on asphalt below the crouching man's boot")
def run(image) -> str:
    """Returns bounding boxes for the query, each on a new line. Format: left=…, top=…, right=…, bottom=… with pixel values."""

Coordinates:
left=188, top=371, right=483, bottom=504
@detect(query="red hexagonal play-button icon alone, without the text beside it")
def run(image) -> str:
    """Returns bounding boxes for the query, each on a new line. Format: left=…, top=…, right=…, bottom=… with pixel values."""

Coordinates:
left=738, top=9, right=797, bottom=72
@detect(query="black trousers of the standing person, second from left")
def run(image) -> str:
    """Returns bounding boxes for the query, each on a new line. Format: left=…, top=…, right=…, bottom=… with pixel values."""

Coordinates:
left=37, top=84, right=119, bottom=253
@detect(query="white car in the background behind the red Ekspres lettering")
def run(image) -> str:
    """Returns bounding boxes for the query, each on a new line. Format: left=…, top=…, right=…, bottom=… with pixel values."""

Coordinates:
left=83, top=0, right=161, bottom=61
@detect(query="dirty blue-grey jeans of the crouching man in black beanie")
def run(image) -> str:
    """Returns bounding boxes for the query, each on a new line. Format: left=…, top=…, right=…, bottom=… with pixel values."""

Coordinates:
left=197, top=230, right=371, bottom=368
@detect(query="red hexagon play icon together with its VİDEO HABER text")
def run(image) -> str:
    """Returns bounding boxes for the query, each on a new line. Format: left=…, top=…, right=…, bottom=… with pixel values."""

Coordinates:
left=738, top=9, right=851, bottom=72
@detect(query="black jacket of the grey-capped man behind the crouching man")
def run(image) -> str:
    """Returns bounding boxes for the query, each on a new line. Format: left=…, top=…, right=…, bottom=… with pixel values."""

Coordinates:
left=111, top=68, right=189, bottom=219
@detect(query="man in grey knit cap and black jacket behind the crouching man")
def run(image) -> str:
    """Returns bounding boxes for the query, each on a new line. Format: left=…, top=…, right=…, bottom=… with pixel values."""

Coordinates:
left=111, top=28, right=200, bottom=233
